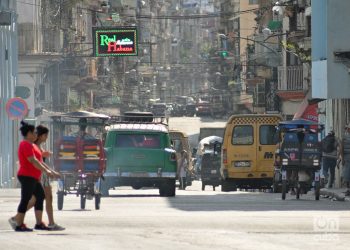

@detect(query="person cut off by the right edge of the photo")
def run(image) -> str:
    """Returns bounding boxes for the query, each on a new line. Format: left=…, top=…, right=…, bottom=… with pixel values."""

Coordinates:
left=340, top=124, right=350, bottom=196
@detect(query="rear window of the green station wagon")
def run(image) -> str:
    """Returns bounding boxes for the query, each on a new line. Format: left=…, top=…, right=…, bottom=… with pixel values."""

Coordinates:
left=116, top=134, right=160, bottom=148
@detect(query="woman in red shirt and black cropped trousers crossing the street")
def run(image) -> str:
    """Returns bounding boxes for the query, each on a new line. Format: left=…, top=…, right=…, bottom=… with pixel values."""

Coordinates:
left=9, top=121, right=57, bottom=232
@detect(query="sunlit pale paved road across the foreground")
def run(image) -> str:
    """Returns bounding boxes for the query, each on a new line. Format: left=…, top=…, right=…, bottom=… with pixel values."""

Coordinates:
left=0, top=182, right=350, bottom=250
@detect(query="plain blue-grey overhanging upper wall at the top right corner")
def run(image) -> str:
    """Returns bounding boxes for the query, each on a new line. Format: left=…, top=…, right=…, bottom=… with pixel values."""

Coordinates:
left=312, top=0, right=350, bottom=99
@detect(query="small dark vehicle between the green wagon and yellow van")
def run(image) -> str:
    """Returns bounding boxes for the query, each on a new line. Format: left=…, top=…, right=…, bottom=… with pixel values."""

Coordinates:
left=201, top=141, right=222, bottom=191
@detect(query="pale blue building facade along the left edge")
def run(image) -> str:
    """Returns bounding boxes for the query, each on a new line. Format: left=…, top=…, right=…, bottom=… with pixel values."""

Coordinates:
left=0, top=0, right=18, bottom=188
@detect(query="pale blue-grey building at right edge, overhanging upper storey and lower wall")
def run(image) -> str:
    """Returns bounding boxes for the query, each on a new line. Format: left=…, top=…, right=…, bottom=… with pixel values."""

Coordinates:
left=312, top=0, right=350, bottom=187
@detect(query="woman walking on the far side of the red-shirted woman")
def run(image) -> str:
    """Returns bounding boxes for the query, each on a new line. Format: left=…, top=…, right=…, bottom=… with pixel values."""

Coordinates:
left=28, top=125, right=65, bottom=231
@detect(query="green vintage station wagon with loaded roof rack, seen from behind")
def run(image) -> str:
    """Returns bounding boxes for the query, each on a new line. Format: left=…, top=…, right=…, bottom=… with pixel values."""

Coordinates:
left=101, top=113, right=177, bottom=197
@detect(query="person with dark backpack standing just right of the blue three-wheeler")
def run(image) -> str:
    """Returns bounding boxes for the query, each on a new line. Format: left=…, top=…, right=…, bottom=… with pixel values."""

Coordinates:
left=321, top=130, right=339, bottom=188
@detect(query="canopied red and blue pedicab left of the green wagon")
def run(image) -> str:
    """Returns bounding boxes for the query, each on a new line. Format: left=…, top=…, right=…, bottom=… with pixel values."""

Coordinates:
left=51, top=111, right=109, bottom=210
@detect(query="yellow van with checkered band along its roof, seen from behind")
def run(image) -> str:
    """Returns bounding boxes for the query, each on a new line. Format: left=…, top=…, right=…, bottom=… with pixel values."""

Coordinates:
left=220, top=114, right=282, bottom=192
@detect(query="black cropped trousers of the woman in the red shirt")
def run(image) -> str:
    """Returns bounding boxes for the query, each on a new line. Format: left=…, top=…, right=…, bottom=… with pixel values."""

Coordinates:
left=17, top=176, right=45, bottom=214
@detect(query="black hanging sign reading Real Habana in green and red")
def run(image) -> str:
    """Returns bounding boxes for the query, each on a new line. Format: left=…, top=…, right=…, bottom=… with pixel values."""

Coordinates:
left=92, top=27, right=138, bottom=56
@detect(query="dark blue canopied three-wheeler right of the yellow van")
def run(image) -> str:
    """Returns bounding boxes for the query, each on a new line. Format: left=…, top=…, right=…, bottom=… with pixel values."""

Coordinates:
left=273, top=119, right=324, bottom=200
